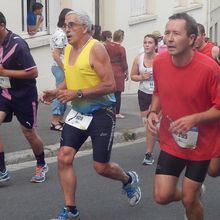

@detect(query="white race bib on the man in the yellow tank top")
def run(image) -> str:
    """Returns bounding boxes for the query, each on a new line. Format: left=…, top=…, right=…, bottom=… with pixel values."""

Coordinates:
left=65, top=109, right=93, bottom=130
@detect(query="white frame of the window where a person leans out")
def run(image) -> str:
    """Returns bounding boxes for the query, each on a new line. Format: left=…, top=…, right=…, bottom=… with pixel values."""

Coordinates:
left=21, top=0, right=49, bottom=38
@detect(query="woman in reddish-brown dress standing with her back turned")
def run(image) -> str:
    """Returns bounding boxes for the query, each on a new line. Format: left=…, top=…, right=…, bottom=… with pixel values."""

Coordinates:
left=105, top=29, right=128, bottom=119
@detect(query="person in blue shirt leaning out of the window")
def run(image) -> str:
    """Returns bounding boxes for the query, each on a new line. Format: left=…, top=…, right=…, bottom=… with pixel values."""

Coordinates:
left=27, top=2, right=44, bottom=35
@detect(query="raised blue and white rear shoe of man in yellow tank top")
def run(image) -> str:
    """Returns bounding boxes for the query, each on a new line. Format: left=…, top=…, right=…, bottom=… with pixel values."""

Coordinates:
left=123, top=171, right=141, bottom=206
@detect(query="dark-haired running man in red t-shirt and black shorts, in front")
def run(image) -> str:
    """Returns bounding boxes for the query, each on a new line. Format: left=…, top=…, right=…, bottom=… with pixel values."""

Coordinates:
left=148, top=13, right=220, bottom=220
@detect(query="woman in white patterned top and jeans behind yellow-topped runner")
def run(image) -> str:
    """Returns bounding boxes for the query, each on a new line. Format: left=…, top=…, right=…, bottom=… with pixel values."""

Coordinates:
left=50, top=8, right=71, bottom=131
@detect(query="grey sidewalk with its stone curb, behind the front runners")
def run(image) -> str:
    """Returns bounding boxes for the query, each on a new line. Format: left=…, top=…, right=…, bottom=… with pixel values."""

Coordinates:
left=3, top=94, right=145, bottom=164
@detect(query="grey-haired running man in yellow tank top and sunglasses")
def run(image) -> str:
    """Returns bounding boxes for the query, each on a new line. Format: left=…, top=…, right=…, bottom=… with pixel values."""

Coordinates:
left=42, top=11, right=141, bottom=219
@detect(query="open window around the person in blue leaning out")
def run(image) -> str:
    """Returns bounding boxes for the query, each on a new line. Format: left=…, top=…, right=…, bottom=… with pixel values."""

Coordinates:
left=21, top=0, right=49, bottom=35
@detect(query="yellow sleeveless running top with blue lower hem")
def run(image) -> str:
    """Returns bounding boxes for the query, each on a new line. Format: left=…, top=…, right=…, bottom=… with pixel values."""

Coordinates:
left=64, top=39, right=115, bottom=114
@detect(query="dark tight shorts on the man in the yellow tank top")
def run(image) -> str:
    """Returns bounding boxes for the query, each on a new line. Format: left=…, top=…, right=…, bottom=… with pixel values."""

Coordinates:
left=60, top=107, right=115, bottom=163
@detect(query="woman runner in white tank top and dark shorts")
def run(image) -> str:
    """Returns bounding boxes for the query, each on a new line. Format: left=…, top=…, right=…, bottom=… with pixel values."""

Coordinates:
left=130, top=34, right=158, bottom=165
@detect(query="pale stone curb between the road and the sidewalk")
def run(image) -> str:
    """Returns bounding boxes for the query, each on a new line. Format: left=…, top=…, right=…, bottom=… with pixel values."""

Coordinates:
left=5, top=127, right=146, bottom=165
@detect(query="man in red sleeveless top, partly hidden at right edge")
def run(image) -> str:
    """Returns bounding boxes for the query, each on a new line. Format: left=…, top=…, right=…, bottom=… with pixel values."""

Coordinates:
left=195, top=23, right=220, bottom=64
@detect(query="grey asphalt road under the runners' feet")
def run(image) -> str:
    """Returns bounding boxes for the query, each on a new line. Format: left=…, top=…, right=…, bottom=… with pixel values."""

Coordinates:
left=0, top=139, right=220, bottom=220
